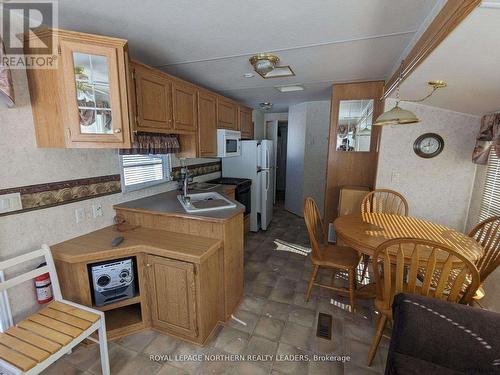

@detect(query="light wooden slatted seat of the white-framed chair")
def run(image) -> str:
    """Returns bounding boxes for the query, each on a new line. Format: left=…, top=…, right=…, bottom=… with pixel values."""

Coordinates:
left=0, top=301, right=100, bottom=371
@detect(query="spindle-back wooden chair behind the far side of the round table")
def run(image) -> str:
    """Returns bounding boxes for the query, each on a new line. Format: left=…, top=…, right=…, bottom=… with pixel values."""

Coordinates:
left=361, top=189, right=409, bottom=216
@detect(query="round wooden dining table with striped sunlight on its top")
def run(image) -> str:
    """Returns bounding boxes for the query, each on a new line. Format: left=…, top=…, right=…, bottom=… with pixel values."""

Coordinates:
left=333, top=213, right=483, bottom=298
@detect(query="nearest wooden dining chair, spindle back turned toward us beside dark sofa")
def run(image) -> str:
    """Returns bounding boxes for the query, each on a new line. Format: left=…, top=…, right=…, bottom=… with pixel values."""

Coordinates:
left=368, top=238, right=479, bottom=366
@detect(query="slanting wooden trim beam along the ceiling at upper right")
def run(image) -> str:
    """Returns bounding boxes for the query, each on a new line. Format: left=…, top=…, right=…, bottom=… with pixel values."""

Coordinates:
left=384, top=0, right=481, bottom=98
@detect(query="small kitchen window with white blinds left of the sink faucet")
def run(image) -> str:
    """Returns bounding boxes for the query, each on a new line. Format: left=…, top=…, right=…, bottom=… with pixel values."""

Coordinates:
left=120, top=155, right=171, bottom=192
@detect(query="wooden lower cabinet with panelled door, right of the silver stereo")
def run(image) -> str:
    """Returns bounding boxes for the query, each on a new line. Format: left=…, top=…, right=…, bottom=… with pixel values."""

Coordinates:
left=146, top=251, right=223, bottom=344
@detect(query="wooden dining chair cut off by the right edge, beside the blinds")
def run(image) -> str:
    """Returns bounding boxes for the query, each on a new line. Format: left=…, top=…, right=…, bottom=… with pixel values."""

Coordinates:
left=469, top=216, right=500, bottom=302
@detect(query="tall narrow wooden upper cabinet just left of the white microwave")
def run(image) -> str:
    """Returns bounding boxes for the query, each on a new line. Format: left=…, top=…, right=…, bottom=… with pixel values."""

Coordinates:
left=198, top=90, right=217, bottom=157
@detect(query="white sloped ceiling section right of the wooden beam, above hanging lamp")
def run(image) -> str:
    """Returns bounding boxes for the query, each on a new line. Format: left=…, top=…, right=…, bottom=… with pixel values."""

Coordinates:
left=394, top=1, right=500, bottom=116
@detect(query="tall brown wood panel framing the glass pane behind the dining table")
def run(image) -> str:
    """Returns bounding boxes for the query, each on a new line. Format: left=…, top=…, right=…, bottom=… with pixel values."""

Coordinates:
left=325, top=81, right=384, bottom=225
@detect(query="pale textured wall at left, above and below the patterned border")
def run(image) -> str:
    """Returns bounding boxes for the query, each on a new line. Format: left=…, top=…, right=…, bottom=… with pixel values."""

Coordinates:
left=0, top=71, right=220, bottom=316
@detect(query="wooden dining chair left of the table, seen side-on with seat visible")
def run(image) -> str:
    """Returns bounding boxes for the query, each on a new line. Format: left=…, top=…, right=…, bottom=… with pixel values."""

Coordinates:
left=304, top=197, right=360, bottom=312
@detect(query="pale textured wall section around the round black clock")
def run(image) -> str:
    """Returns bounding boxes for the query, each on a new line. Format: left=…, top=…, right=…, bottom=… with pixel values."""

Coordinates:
left=377, top=100, right=480, bottom=231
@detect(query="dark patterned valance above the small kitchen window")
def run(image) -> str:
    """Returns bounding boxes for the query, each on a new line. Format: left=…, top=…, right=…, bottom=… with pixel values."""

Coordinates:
left=120, top=132, right=181, bottom=155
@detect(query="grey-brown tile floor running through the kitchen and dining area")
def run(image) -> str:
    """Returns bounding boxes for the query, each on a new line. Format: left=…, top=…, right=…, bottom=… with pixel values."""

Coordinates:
left=44, top=205, right=388, bottom=375
